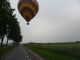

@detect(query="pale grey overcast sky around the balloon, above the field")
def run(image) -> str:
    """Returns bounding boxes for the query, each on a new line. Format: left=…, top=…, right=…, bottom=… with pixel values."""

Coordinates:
left=10, top=0, right=80, bottom=43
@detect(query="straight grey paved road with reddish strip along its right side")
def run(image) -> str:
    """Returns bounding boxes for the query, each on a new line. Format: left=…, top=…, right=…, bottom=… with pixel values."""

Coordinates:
left=0, top=45, right=42, bottom=60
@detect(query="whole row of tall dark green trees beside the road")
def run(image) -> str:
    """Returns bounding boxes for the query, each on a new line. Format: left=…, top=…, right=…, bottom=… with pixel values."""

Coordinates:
left=0, top=0, right=22, bottom=47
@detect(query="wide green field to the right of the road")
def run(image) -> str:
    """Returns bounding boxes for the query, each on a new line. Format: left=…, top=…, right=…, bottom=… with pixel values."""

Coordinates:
left=24, top=42, right=80, bottom=60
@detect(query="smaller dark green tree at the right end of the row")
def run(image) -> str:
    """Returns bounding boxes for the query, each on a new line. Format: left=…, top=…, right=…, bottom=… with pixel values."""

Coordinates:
left=7, top=15, right=22, bottom=43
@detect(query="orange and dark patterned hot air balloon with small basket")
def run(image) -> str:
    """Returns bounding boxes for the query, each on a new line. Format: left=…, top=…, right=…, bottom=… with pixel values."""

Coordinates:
left=18, top=0, right=39, bottom=25
